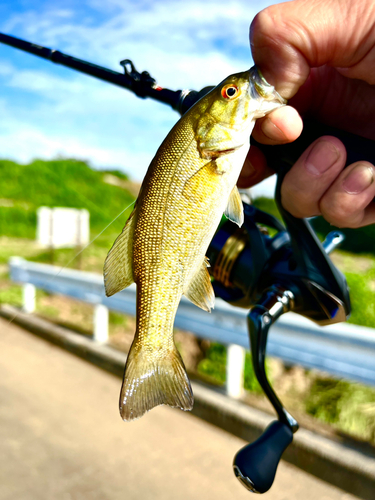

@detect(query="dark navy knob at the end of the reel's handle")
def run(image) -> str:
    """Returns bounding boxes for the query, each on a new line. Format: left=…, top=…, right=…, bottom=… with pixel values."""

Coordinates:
left=233, top=420, right=293, bottom=493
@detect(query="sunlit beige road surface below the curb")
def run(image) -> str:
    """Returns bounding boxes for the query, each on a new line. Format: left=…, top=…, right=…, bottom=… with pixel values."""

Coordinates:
left=0, top=318, right=357, bottom=500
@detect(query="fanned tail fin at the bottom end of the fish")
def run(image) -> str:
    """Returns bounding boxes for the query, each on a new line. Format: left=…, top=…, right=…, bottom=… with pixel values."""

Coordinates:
left=120, top=337, right=194, bottom=421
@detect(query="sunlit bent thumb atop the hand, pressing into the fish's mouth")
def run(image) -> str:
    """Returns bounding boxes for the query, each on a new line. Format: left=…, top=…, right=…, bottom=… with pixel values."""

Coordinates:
left=250, top=0, right=375, bottom=99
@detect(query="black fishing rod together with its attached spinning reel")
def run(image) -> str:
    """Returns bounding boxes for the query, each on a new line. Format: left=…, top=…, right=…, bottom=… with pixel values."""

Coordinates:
left=0, top=34, right=375, bottom=493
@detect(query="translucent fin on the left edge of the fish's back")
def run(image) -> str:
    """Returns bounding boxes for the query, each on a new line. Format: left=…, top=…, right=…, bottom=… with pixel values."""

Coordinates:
left=104, top=208, right=137, bottom=297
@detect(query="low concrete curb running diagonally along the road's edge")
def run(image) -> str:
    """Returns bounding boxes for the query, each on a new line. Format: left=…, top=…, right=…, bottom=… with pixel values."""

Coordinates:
left=0, top=306, right=375, bottom=500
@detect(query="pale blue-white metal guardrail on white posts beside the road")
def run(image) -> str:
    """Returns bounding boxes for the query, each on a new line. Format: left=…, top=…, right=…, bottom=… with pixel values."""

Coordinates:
left=9, top=257, right=375, bottom=397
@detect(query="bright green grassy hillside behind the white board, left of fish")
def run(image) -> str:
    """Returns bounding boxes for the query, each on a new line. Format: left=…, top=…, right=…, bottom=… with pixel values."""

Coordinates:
left=0, top=159, right=134, bottom=238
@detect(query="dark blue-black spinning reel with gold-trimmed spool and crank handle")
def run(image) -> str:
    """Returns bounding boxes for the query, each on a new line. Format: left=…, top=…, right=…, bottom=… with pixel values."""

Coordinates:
left=208, top=175, right=350, bottom=493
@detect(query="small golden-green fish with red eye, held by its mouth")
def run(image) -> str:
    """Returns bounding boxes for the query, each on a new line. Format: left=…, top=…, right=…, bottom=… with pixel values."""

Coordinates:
left=104, top=67, right=286, bottom=421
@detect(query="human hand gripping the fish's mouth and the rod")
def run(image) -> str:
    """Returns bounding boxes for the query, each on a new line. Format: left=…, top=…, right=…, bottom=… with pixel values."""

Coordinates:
left=239, top=0, right=375, bottom=227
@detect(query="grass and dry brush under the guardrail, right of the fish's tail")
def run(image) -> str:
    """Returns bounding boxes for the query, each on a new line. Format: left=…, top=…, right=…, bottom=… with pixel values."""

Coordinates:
left=198, top=344, right=375, bottom=446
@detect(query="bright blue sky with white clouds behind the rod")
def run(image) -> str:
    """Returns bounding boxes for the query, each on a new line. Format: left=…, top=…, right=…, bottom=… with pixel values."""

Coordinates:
left=0, top=0, right=282, bottom=196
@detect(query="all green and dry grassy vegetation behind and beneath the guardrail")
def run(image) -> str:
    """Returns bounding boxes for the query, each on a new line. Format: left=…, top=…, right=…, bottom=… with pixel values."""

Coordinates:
left=0, top=159, right=375, bottom=445
